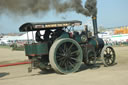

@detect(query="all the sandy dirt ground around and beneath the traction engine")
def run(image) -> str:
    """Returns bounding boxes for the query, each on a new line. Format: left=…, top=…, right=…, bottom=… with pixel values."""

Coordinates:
left=0, top=47, right=128, bottom=85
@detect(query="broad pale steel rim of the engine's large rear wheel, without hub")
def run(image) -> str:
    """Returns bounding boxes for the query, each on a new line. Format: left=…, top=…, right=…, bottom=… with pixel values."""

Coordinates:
left=50, top=38, right=83, bottom=74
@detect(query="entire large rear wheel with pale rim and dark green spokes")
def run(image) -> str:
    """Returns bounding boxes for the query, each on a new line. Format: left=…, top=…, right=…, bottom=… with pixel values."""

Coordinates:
left=49, top=38, right=83, bottom=74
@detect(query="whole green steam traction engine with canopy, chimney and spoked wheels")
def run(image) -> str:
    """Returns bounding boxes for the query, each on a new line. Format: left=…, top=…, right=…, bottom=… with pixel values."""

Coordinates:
left=19, top=17, right=116, bottom=74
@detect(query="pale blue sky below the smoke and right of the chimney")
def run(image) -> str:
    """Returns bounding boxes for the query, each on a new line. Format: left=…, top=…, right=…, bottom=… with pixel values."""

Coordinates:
left=0, top=0, right=128, bottom=33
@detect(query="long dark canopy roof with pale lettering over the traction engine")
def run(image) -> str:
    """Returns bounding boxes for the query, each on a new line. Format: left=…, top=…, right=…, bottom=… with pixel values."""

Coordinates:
left=19, top=20, right=82, bottom=32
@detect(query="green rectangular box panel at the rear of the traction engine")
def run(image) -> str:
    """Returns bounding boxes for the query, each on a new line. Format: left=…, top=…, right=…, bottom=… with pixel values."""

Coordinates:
left=25, top=43, right=48, bottom=56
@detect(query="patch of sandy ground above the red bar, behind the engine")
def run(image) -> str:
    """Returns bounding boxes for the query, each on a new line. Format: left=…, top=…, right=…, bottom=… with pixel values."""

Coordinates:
left=0, top=48, right=28, bottom=65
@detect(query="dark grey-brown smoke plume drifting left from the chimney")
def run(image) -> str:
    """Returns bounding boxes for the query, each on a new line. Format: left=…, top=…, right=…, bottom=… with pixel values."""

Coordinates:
left=0, top=0, right=97, bottom=16
